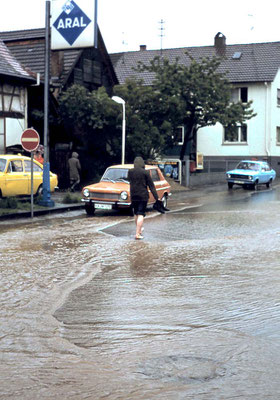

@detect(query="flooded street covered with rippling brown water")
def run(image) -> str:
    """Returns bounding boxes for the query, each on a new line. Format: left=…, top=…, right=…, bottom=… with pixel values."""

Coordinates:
left=0, top=188, right=280, bottom=400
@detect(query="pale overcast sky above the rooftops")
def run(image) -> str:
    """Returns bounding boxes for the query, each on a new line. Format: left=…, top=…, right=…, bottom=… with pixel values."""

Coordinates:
left=0, top=0, right=280, bottom=53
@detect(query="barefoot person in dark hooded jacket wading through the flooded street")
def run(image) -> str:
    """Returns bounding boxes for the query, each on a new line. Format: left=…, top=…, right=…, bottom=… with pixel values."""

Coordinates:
left=128, top=157, right=158, bottom=240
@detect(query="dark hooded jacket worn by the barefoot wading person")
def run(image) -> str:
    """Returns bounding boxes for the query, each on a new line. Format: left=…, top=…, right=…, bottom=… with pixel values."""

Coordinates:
left=128, top=157, right=158, bottom=201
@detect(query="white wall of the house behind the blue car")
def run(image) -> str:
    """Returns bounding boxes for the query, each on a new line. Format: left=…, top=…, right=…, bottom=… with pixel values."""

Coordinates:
left=190, top=81, right=280, bottom=186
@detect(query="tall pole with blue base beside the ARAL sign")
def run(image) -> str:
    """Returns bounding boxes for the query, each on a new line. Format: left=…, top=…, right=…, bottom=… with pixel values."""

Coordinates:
left=40, top=0, right=54, bottom=207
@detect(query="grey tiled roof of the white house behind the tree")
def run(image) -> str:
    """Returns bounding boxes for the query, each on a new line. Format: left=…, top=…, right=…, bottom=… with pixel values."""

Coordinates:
left=110, top=42, right=280, bottom=85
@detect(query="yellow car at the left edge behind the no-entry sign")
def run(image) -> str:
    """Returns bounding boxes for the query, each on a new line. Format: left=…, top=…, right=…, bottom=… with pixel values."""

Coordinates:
left=0, top=154, right=57, bottom=198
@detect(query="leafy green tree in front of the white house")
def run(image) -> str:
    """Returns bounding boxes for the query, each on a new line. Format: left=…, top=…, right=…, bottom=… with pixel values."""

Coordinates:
left=139, top=56, right=256, bottom=159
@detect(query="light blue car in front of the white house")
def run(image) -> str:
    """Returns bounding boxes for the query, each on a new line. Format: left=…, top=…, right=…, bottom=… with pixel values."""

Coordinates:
left=226, top=160, right=276, bottom=189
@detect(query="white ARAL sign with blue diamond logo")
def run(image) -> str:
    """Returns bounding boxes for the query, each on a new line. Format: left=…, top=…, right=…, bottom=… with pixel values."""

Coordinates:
left=51, top=0, right=95, bottom=50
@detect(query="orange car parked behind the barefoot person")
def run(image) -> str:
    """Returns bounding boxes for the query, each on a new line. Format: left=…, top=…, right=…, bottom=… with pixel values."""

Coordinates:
left=82, top=164, right=170, bottom=215
